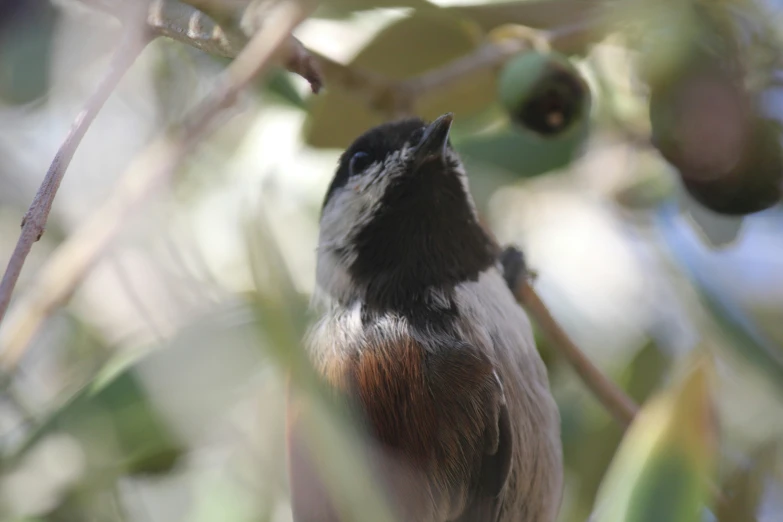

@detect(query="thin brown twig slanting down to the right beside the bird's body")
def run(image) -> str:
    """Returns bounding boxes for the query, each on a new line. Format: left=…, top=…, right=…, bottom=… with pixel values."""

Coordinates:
left=514, top=277, right=639, bottom=426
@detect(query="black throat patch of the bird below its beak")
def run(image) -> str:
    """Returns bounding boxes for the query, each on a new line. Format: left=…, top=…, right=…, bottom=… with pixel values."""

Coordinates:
left=349, top=154, right=498, bottom=318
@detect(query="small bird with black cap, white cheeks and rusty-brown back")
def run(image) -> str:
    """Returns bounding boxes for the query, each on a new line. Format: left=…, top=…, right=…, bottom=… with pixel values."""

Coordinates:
left=289, top=114, right=563, bottom=522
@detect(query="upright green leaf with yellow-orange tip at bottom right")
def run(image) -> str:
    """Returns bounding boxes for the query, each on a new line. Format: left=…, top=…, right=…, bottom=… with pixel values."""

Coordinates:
left=591, top=357, right=717, bottom=522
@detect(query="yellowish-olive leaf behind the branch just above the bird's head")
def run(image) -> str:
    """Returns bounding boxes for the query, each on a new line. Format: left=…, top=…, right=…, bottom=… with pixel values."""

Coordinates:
left=305, top=10, right=496, bottom=148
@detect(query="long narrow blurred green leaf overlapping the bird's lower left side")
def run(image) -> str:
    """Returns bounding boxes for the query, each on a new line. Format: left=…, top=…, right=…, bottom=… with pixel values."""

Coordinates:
left=245, top=205, right=402, bottom=522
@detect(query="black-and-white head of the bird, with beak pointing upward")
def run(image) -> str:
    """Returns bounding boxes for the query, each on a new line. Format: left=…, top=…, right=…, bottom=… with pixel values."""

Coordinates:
left=317, top=113, right=497, bottom=307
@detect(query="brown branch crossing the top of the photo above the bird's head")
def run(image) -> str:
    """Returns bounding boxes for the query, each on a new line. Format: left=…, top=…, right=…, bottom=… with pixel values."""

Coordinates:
left=78, top=0, right=603, bottom=109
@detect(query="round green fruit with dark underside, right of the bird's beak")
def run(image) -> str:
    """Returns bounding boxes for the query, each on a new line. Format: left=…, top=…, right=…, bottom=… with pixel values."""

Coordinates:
left=498, top=51, right=590, bottom=137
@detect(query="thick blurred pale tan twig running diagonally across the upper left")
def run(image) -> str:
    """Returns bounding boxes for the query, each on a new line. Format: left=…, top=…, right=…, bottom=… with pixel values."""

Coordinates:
left=0, top=1, right=308, bottom=373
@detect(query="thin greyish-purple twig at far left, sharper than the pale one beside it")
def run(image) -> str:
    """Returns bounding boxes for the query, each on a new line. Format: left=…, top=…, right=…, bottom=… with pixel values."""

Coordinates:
left=0, top=21, right=149, bottom=323
